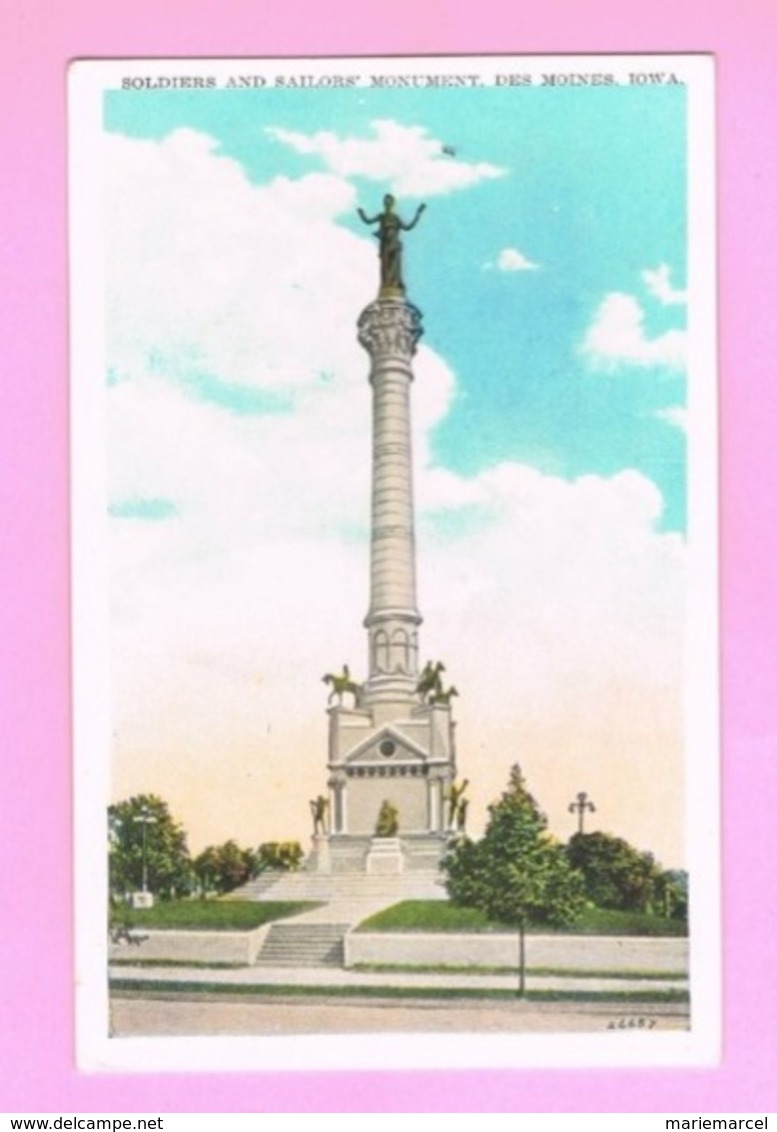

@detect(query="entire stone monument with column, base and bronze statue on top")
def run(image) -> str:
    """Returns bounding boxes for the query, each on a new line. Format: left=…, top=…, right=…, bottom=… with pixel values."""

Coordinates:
left=310, top=196, right=458, bottom=874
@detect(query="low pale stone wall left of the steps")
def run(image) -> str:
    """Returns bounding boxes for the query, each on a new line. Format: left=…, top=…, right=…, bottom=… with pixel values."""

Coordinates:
left=109, top=924, right=272, bottom=967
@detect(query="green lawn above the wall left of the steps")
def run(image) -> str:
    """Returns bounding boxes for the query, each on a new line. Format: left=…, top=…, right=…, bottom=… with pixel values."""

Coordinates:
left=117, top=900, right=317, bottom=932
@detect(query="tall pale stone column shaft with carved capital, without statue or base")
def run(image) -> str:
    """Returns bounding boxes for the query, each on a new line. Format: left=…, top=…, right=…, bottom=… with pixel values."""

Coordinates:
left=358, top=297, right=422, bottom=704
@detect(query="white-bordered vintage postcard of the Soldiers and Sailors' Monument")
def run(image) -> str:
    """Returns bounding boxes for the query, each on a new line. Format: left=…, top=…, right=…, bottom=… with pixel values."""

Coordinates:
left=70, top=55, right=720, bottom=1071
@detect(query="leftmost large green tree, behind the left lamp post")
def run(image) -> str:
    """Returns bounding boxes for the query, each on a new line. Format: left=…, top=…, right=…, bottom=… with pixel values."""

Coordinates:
left=108, top=794, right=193, bottom=900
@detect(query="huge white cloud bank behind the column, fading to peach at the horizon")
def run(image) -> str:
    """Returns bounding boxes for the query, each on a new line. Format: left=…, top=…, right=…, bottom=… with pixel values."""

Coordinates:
left=101, top=134, right=683, bottom=859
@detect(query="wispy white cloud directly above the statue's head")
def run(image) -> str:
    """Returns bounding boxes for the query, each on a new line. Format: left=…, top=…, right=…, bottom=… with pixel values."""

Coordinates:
left=266, top=119, right=505, bottom=197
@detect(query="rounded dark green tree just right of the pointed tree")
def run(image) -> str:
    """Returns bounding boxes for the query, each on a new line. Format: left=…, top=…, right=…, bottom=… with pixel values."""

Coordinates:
left=566, top=832, right=661, bottom=912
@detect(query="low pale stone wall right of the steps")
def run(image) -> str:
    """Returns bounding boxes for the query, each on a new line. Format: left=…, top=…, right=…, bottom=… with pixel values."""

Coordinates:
left=345, top=932, right=688, bottom=971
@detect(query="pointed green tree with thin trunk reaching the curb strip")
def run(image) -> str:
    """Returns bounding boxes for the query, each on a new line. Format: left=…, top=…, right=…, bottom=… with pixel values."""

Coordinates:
left=443, top=766, right=584, bottom=995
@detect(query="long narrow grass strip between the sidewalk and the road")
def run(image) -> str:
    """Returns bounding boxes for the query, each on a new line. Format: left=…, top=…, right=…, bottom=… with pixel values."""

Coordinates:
left=110, top=978, right=689, bottom=1003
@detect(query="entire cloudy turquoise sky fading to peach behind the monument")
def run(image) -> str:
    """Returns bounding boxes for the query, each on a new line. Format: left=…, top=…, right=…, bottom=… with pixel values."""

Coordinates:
left=99, top=70, right=703, bottom=864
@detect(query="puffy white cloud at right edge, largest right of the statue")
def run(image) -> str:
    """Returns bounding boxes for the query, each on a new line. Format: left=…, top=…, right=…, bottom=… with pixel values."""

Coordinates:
left=581, top=291, right=686, bottom=372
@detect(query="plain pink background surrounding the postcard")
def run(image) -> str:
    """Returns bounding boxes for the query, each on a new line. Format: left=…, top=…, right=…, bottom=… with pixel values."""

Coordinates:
left=0, top=0, right=777, bottom=1113
